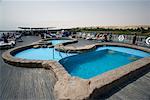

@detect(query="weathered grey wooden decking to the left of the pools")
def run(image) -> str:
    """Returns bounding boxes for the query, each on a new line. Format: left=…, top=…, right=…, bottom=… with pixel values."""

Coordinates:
left=0, top=36, right=56, bottom=100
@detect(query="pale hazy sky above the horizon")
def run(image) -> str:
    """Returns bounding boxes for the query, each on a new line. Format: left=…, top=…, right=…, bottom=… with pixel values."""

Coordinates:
left=0, top=0, right=150, bottom=30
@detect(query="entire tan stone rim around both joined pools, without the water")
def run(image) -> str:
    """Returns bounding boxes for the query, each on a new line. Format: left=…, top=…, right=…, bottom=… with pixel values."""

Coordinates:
left=2, top=41, right=150, bottom=100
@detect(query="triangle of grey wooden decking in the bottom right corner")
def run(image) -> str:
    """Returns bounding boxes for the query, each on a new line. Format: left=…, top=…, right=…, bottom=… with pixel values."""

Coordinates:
left=108, top=72, right=150, bottom=100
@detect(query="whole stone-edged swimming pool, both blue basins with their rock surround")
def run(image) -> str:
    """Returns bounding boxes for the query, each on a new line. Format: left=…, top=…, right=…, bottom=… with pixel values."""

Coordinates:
left=2, top=43, right=150, bottom=99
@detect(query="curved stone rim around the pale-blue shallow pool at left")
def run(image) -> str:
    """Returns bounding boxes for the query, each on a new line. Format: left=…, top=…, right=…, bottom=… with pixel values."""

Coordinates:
left=2, top=38, right=77, bottom=68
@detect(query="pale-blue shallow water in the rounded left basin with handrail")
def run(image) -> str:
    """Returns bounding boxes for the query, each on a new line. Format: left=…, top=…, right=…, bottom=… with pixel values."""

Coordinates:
left=15, top=48, right=75, bottom=61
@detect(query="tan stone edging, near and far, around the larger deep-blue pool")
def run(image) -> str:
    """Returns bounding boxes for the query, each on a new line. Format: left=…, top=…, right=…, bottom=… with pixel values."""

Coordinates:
left=49, top=42, right=150, bottom=100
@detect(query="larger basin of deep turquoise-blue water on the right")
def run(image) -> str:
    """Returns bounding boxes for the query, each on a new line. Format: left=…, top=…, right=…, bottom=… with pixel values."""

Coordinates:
left=59, top=46, right=150, bottom=79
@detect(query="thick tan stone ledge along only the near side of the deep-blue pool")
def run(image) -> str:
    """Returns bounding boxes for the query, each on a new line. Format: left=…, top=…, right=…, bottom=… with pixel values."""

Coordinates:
left=51, top=57, right=150, bottom=100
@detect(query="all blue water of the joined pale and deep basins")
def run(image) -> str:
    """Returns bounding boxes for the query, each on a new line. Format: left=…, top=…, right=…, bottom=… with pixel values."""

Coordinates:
left=15, top=46, right=150, bottom=79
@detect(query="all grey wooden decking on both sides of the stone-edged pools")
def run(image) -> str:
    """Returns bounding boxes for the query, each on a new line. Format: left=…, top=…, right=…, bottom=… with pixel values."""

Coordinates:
left=0, top=36, right=150, bottom=100
